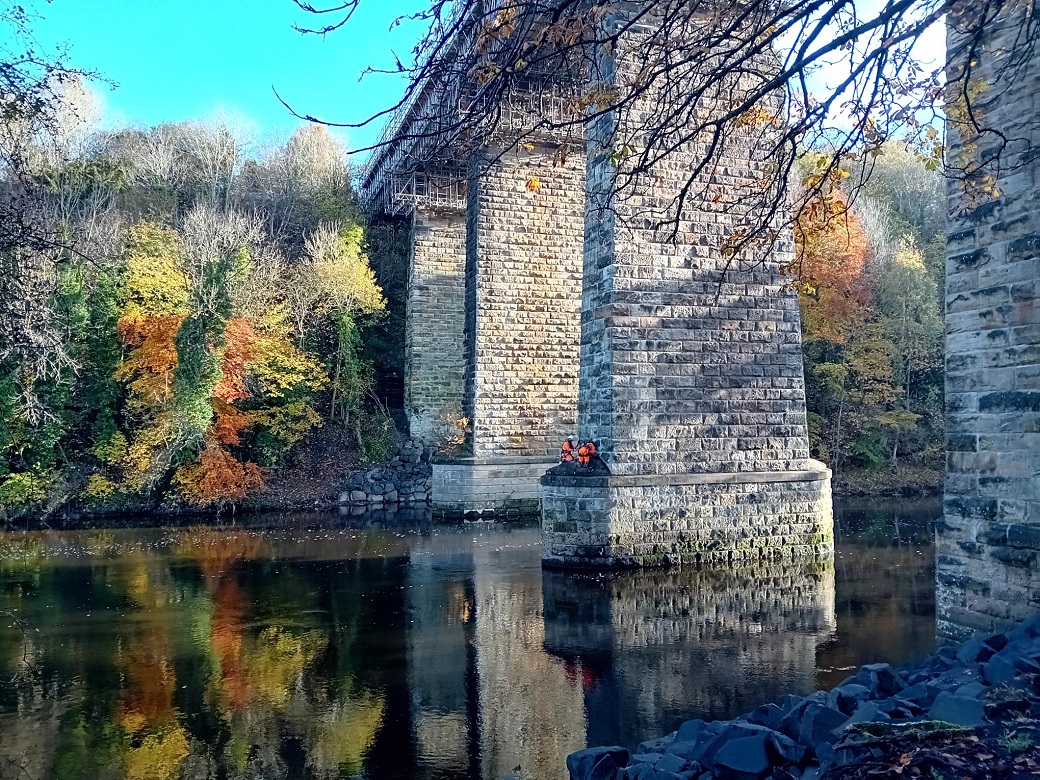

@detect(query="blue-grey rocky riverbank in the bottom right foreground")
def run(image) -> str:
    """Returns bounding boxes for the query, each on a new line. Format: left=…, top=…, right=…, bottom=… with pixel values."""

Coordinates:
left=567, top=618, right=1040, bottom=780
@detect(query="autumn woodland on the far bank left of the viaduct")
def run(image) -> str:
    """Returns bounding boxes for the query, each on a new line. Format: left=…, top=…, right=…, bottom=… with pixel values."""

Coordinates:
left=0, top=80, right=393, bottom=515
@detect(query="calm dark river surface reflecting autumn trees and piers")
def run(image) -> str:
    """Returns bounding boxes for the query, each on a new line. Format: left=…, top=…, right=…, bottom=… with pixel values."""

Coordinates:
left=0, top=501, right=940, bottom=780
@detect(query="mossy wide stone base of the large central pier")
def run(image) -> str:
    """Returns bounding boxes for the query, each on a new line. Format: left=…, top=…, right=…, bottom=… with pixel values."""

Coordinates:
left=542, top=461, right=834, bottom=569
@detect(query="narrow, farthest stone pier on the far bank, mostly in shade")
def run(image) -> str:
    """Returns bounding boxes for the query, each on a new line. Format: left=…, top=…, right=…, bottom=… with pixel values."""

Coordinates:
left=405, top=210, right=466, bottom=441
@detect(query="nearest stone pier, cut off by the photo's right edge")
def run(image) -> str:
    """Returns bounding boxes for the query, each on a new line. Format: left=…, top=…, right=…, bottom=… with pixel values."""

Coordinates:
left=936, top=4, right=1040, bottom=638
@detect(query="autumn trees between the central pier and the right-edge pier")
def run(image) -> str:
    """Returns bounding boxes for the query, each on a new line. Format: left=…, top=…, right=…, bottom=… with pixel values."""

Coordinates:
left=794, top=142, right=946, bottom=490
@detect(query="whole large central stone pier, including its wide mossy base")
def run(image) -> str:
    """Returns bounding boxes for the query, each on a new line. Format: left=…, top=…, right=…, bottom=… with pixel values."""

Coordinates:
left=542, top=19, right=833, bottom=568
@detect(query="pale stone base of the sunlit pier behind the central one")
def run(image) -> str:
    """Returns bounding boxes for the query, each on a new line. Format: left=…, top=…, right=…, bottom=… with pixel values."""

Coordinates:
left=430, top=456, right=558, bottom=520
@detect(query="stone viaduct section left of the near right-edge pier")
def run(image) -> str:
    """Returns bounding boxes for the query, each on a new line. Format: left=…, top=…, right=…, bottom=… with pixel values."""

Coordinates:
left=362, top=4, right=832, bottom=567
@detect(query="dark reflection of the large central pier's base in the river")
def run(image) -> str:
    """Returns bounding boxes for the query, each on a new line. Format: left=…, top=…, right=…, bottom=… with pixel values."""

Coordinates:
left=542, top=562, right=836, bottom=745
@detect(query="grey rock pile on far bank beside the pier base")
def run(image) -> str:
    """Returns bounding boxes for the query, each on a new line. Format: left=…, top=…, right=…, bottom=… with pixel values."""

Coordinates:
left=339, top=441, right=434, bottom=508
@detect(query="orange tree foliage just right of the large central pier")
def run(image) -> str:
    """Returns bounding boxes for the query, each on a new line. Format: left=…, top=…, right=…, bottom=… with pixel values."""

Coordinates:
left=795, top=192, right=872, bottom=344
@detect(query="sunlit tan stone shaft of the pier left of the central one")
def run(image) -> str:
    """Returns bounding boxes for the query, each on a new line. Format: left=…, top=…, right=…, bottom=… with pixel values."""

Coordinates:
left=465, top=149, right=584, bottom=461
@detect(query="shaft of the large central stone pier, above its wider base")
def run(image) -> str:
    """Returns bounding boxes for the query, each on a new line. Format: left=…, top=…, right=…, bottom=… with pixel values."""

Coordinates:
left=578, top=50, right=809, bottom=482
